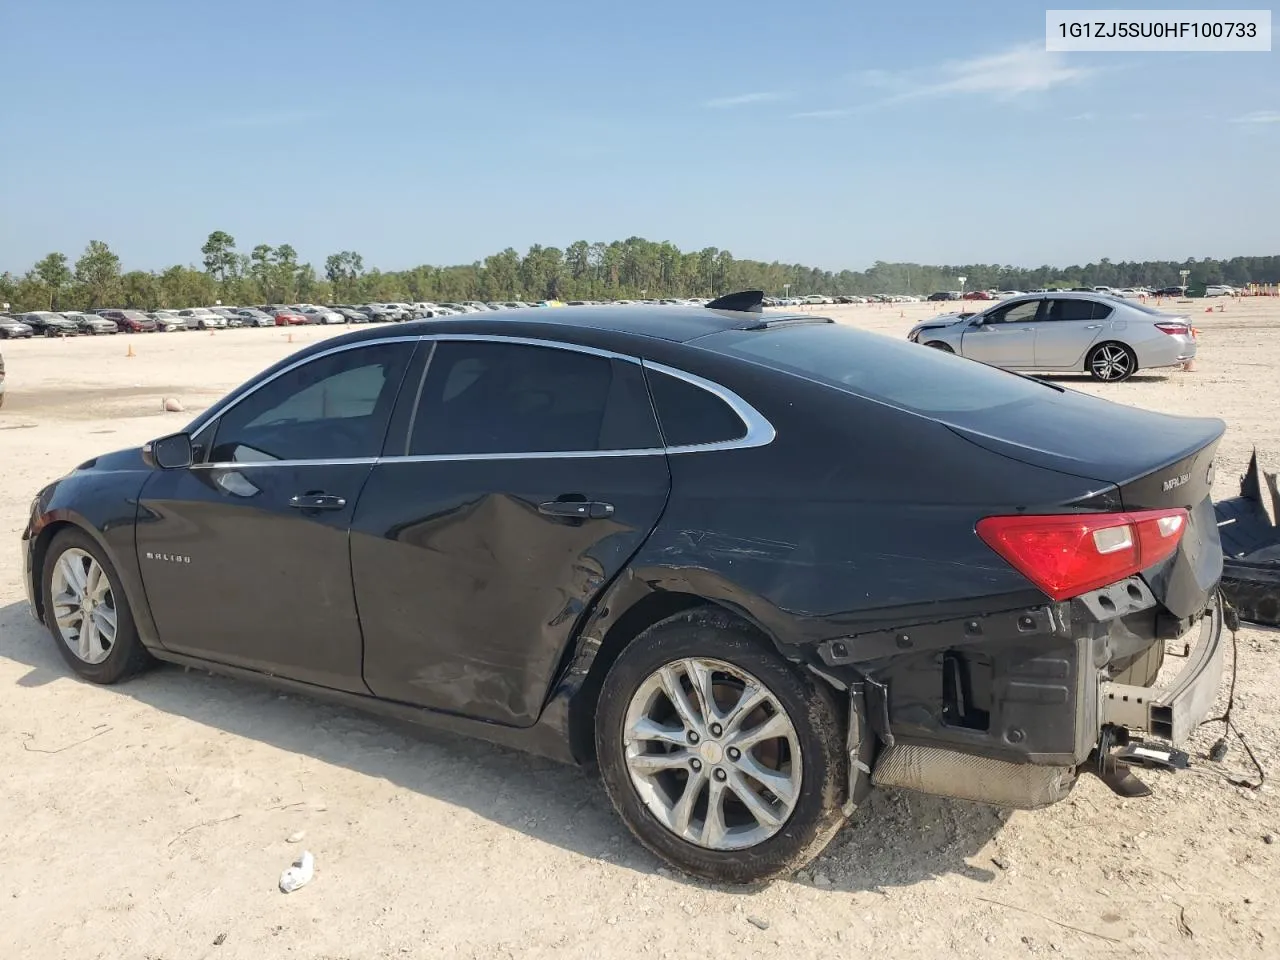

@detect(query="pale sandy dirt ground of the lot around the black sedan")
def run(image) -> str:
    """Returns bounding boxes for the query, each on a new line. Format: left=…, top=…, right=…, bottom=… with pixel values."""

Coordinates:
left=0, top=300, right=1280, bottom=960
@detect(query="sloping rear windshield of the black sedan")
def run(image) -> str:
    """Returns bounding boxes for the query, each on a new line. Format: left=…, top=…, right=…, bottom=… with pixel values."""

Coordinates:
left=695, top=324, right=1055, bottom=415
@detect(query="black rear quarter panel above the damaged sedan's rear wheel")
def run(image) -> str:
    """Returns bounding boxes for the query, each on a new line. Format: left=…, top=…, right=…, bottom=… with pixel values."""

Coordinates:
left=604, top=364, right=1105, bottom=660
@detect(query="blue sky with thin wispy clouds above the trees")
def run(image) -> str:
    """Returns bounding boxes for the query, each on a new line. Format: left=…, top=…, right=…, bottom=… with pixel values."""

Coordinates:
left=0, top=0, right=1280, bottom=273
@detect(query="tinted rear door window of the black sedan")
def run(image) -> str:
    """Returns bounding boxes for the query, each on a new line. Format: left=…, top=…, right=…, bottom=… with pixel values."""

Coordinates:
left=408, top=340, right=660, bottom=456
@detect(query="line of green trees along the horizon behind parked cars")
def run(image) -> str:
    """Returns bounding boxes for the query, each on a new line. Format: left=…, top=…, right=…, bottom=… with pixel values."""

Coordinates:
left=0, top=230, right=1280, bottom=310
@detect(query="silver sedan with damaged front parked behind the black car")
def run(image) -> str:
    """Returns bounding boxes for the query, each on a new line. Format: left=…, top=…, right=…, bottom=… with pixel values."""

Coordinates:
left=908, top=293, right=1196, bottom=383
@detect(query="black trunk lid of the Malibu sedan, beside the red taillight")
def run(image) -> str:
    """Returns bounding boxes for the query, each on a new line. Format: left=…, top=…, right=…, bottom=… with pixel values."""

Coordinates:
left=941, top=390, right=1226, bottom=618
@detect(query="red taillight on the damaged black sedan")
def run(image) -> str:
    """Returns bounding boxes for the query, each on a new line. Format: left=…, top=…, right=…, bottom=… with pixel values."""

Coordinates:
left=978, top=509, right=1187, bottom=600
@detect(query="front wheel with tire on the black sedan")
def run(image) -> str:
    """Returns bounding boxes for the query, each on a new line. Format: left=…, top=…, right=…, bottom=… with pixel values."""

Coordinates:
left=41, top=529, right=151, bottom=684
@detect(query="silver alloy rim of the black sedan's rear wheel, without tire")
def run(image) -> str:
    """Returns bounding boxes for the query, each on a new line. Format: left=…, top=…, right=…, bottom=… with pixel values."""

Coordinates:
left=622, top=658, right=801, bottom=850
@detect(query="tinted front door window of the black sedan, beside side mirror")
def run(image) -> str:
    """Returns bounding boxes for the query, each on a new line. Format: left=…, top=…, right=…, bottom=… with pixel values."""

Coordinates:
left=209, top=343, right=412, bottom=462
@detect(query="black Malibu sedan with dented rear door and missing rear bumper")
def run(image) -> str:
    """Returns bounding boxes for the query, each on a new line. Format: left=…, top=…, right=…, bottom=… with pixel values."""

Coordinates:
left=23, top=294, right=1224, bottom=882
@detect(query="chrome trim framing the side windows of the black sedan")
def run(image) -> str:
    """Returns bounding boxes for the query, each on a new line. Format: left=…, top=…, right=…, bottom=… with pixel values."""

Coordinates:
left=187, top=333, right=777, bottom=470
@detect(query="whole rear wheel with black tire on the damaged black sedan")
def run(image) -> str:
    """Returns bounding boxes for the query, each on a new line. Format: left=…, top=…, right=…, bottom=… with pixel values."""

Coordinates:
left=595, top=608, right=872, bottom=883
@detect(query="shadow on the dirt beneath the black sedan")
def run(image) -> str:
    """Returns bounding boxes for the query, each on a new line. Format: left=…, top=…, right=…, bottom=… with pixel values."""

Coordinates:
left=0, top=603, right=1009, bottom=893
